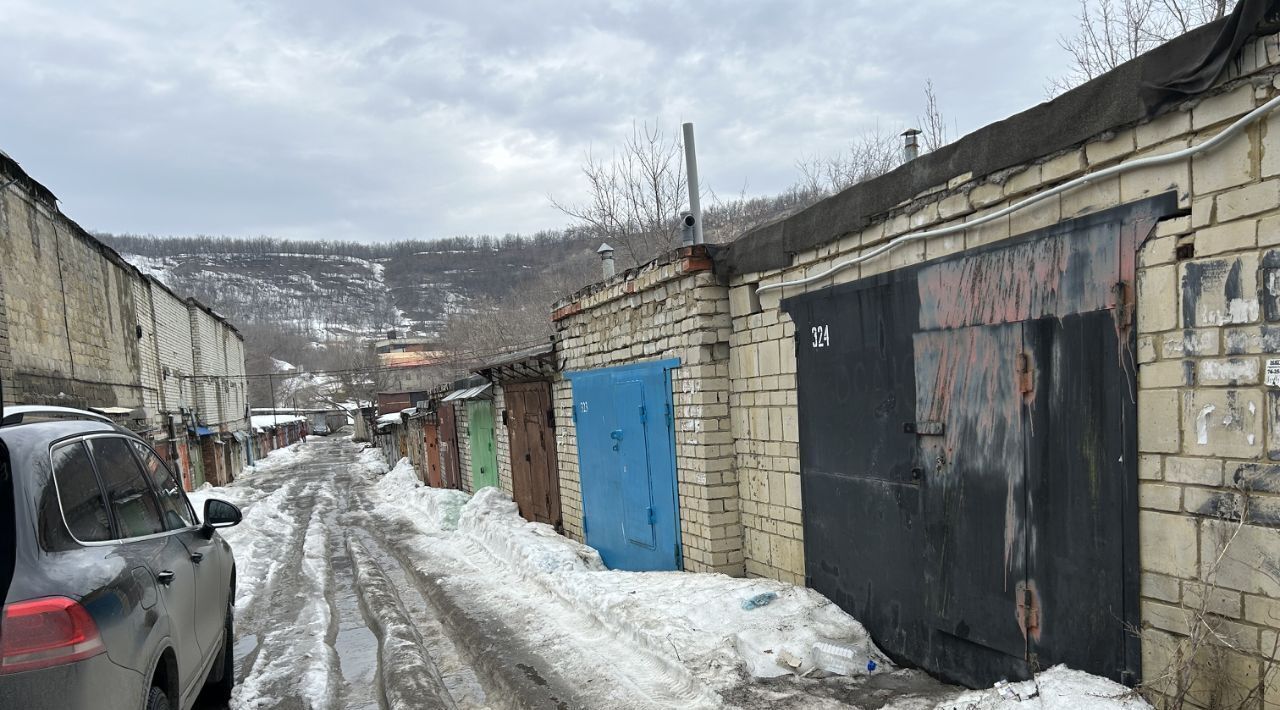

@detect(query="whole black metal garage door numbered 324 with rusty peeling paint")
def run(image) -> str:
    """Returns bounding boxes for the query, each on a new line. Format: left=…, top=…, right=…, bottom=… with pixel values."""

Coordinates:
left=783, top=196, right=1175, bottom=686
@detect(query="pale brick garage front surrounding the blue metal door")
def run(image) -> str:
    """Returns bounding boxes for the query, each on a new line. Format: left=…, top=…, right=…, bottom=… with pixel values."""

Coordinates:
left=552, top=248, right=742, bottom=574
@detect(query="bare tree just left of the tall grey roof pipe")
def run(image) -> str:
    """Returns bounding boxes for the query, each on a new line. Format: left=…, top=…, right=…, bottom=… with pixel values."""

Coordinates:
left=550, top=123, right=687, bottom=264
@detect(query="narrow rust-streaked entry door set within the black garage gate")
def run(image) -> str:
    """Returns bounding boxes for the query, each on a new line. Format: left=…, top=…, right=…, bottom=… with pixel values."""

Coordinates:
left=914, top=324, right=1027, bottom=659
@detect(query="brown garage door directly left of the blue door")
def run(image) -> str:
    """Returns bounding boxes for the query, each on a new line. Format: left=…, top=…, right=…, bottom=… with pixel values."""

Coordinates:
left=503, top=383, right=561, bottom=530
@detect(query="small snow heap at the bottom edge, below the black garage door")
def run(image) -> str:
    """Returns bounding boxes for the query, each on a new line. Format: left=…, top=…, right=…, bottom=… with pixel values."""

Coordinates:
left=926, top=665, right=1151, bottom=710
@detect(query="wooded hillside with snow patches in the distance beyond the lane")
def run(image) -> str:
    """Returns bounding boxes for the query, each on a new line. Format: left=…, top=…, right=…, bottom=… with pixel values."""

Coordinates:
left=100, top=234, right=595, bottom=344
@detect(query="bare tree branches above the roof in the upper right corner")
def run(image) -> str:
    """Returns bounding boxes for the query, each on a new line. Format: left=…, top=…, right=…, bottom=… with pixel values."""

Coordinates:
left=1048, top=0, right=1235, bottom=95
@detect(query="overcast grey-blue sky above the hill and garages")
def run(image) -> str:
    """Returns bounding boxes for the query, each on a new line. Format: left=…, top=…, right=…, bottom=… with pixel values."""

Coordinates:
left=0, top=0, right=1075, bottom=241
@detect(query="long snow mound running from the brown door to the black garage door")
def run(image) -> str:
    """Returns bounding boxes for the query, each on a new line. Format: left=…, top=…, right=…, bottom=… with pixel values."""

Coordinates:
left=458, top=489, right=891, bottom=687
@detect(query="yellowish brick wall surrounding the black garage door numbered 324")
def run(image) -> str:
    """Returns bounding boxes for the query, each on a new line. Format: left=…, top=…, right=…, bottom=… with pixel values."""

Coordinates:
left=730, top=36, right=1280, bottom=709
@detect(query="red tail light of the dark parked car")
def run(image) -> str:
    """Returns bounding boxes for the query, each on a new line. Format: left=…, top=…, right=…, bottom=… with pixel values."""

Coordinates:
left=0, top=596, right=106, bottom=675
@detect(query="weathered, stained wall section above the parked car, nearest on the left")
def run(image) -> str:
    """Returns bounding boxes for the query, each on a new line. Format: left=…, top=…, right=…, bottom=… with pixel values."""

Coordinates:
left=0, top=177, right=142, bottom=408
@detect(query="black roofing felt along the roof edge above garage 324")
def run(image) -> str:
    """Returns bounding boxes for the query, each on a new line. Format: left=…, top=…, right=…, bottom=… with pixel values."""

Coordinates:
left=716, top=0, right=1280, bottom=276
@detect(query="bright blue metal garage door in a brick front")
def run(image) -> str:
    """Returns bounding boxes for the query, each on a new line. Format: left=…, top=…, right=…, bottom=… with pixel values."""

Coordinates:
left=568, top=359, right=680, bottom=571
